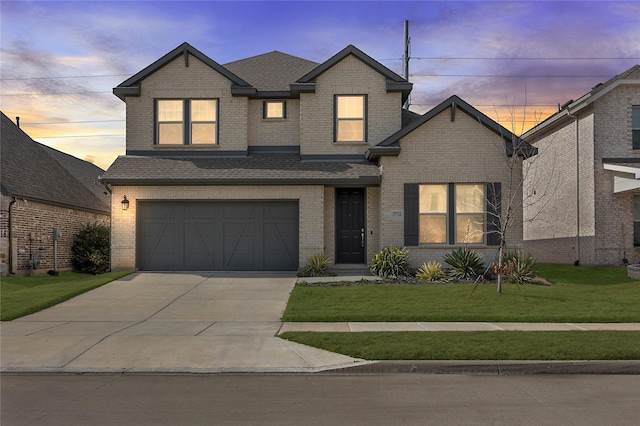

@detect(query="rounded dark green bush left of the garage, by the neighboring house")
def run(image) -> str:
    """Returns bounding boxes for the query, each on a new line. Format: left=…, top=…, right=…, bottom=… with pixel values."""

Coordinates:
left=71, top=223, right=109, bottom=275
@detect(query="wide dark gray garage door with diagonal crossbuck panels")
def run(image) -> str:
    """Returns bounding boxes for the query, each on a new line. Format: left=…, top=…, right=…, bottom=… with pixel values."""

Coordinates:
left=137, top=201, right=298, bottom=271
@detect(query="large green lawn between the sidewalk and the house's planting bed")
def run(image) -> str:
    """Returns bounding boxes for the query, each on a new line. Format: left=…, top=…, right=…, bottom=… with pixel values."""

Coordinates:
left=283, top=265, right=640, bottom=322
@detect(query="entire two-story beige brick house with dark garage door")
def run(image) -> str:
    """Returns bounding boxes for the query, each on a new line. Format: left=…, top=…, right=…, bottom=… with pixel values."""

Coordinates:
left=102, top=43, right=533, bottom=271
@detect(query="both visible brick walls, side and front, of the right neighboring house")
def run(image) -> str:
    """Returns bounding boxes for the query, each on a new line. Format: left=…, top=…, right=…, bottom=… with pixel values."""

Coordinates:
left=524, top=81, right=640, bottom=266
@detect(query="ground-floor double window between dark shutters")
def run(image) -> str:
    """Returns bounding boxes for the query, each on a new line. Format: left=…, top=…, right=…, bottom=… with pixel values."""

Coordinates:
left=418, top=183, right=486, bottom=244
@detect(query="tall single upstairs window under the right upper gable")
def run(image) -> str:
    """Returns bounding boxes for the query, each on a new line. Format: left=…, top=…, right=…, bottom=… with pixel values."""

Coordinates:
left=334, top=95, right=367, bottom=142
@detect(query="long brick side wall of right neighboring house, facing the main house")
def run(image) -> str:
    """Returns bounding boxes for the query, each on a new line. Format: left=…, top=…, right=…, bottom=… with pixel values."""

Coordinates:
left=523, top=110, right=596, bottom=264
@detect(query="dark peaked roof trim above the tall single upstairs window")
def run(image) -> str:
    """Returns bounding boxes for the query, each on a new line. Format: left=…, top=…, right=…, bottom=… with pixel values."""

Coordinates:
left=290, top=44, right=413, bottom=102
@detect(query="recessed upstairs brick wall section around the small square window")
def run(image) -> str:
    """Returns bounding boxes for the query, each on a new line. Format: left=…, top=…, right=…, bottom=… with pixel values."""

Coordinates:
left=248, top=99, right=300, bottom=146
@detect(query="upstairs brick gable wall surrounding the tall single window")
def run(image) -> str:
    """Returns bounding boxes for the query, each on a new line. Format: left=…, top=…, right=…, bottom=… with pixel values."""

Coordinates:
left=300, top=56, right=402, bottom=155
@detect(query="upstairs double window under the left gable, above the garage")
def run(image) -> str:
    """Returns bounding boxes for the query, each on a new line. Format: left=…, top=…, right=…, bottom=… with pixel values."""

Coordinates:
left=156, top=99, right=218, bottom=145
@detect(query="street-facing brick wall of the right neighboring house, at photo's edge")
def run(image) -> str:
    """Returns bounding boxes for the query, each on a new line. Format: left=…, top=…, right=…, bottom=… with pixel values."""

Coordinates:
left=593, top=85, right=640, bottom=265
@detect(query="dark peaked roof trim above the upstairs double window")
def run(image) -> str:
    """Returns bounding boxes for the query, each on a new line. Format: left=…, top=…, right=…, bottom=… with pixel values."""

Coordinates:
left=113, top=42, right=252, bottom=100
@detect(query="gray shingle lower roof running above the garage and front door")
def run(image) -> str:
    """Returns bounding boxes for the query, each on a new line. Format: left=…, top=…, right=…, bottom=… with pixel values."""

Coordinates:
left=102, top=153, right=380, bottom=185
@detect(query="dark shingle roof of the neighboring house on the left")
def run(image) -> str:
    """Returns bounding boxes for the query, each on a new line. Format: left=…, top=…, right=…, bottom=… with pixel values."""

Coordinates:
left=0, top=113, right=110, bottom=213
